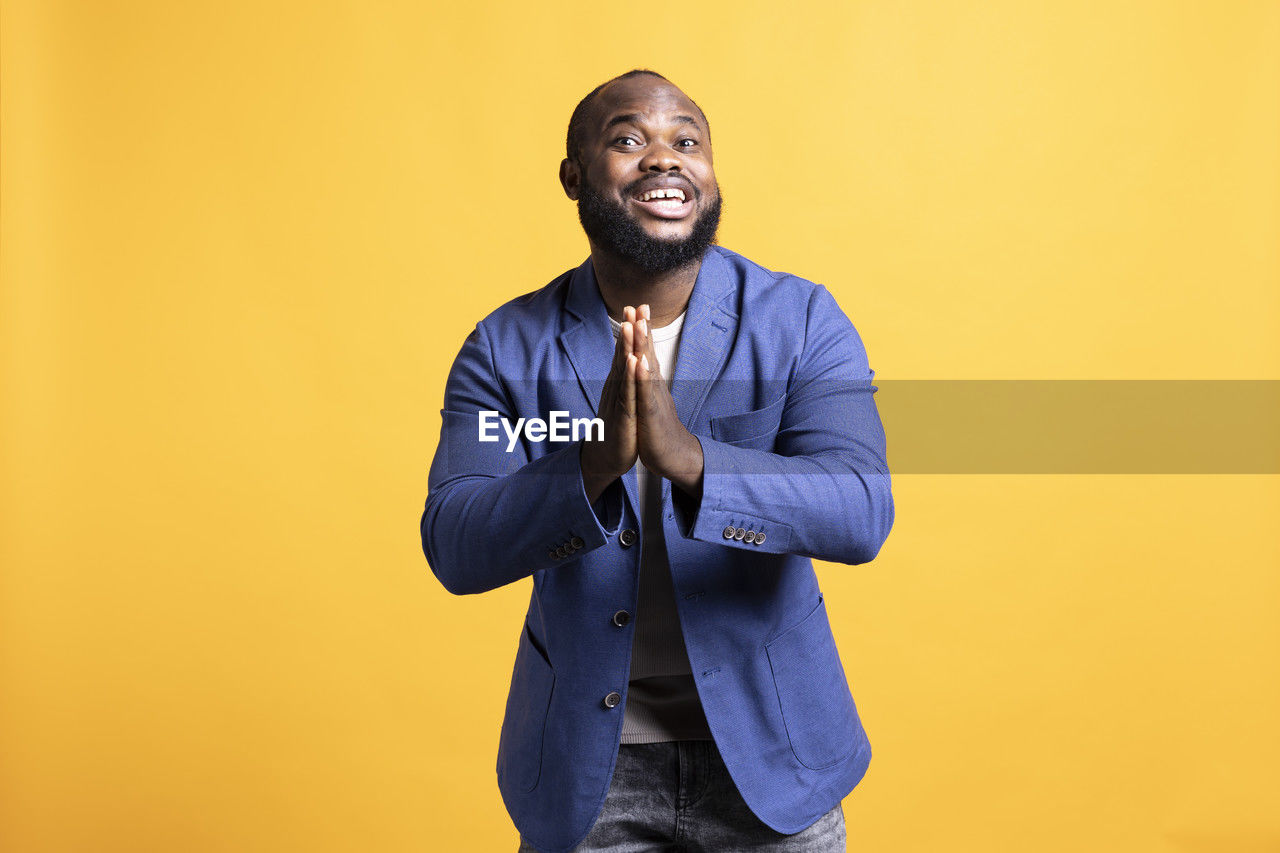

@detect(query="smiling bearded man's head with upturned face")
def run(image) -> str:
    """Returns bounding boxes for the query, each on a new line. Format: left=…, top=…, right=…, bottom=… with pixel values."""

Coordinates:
left=561, top=76, right=721, bottom=273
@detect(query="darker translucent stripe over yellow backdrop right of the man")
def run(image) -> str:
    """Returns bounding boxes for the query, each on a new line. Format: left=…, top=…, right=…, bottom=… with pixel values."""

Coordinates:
left=876, top=379, right=1280, bottom=474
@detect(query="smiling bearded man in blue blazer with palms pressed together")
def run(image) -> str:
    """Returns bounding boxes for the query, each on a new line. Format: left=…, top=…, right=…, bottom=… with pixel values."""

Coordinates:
left=421, top=70, right=893, bottom=853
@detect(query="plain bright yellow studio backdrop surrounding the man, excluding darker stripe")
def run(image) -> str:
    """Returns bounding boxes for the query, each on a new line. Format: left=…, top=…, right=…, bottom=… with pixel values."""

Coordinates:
left=0, top=0, right=1280, bottom=853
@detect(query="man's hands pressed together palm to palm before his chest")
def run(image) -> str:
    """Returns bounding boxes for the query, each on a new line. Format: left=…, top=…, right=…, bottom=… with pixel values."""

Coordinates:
left=579, top=305, right=703, bottom=503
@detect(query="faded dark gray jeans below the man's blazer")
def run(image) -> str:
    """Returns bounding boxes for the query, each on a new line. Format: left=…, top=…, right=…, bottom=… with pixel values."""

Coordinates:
left=520, top=740, right=845, bottom=853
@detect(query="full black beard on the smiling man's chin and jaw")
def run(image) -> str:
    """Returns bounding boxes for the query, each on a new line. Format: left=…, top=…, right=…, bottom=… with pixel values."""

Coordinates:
left=577, top=175, right=721, bottom=274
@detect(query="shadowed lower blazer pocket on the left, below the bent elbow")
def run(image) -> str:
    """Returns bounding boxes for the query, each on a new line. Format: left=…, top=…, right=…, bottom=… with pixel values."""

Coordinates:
left=498, top=624, right=556, bottom=793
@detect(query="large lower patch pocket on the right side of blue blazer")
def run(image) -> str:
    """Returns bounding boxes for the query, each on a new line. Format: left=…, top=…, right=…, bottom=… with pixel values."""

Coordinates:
left=764, top=593, right=860, bottom=770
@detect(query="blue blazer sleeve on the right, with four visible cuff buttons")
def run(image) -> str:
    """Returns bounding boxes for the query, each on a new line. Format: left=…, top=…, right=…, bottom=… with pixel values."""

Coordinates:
left=675, top=286, right=893, bottom=564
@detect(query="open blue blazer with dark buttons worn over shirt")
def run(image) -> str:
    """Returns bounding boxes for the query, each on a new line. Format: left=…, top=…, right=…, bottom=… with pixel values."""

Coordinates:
left=421, top=247, right=893, bottom=853
